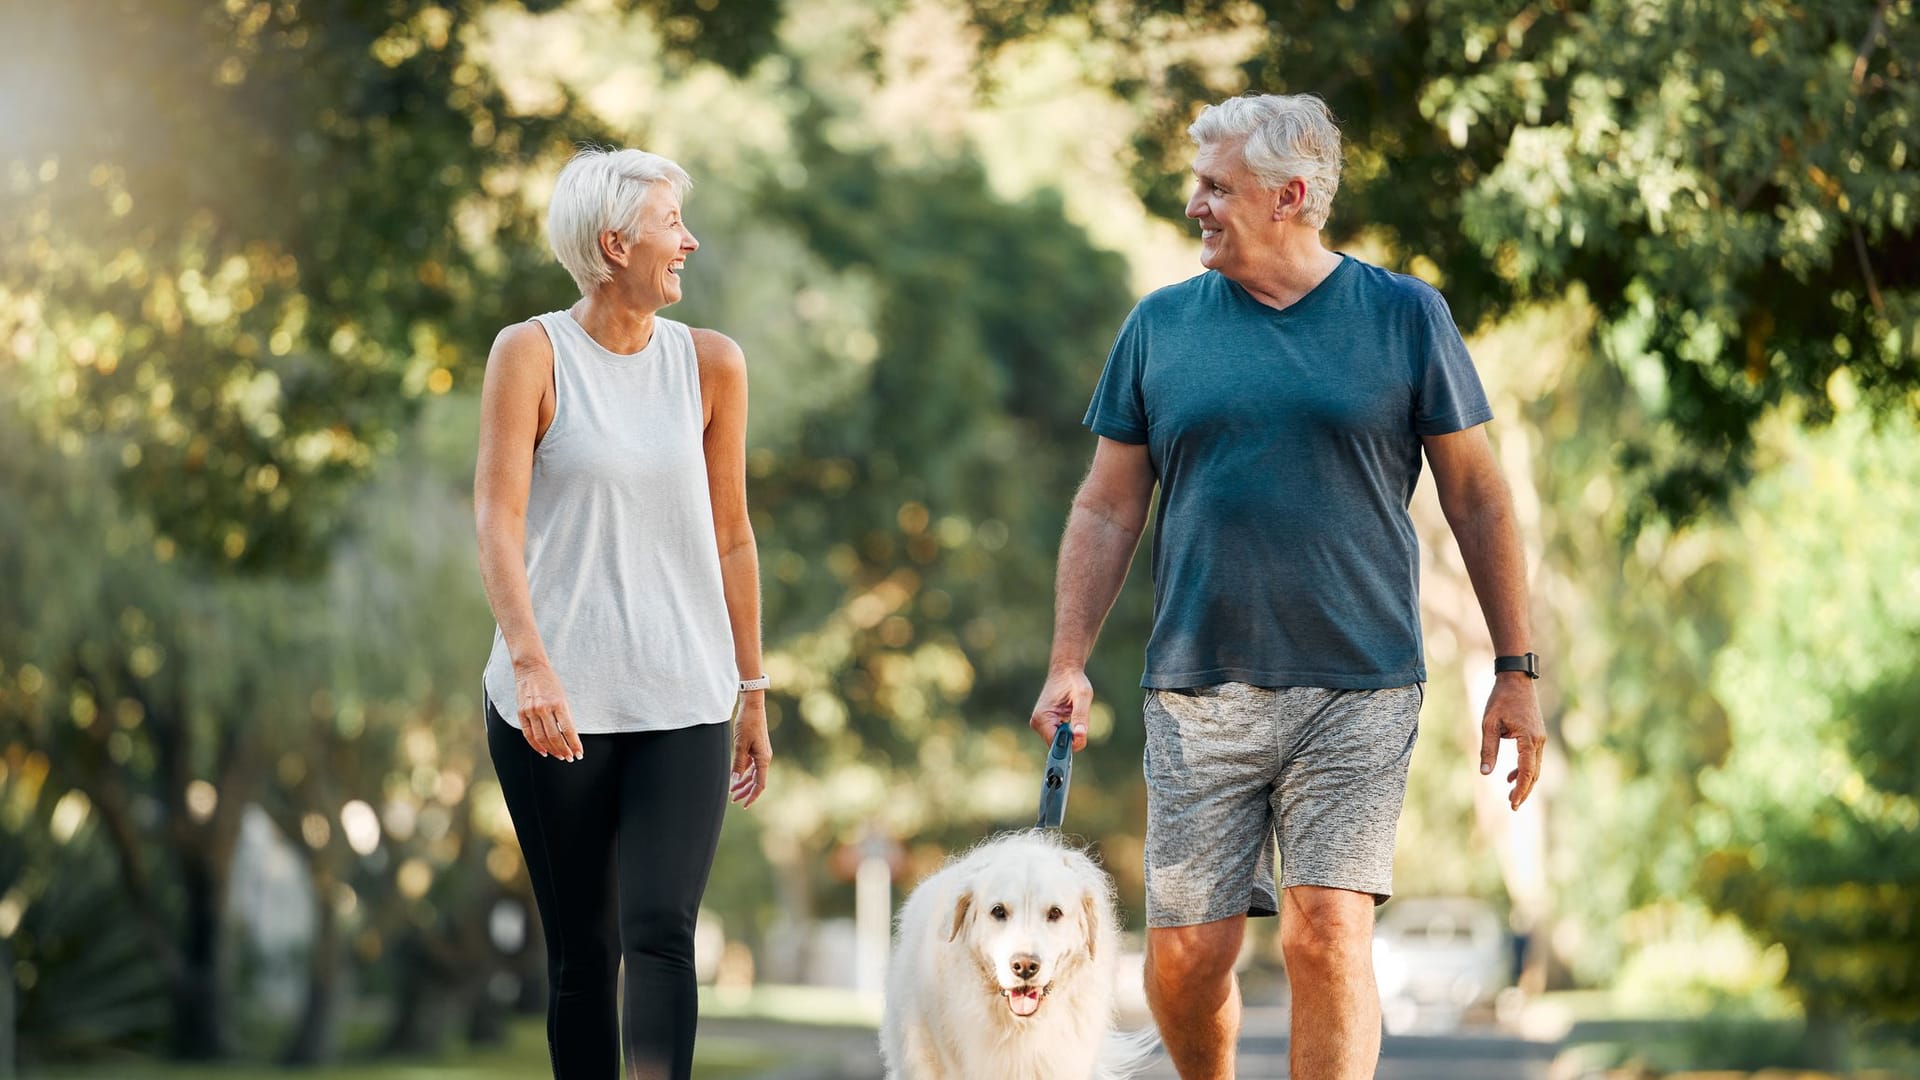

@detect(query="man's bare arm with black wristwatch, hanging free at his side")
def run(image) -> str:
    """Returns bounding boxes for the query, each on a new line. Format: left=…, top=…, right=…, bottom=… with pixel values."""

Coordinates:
left=1421, top=425, right=1548, bottom=809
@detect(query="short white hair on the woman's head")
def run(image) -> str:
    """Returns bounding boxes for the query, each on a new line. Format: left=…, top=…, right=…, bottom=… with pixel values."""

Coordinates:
left=547, top=146, right=693, bottom=296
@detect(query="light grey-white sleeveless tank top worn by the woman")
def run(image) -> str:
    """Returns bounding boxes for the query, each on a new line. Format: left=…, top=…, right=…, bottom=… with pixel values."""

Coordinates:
left=486, top=311, right=739, bottom=734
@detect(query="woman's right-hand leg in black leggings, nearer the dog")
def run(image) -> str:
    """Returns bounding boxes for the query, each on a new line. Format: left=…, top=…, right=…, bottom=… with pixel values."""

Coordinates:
left=616, top=724, right=732, bottom=1080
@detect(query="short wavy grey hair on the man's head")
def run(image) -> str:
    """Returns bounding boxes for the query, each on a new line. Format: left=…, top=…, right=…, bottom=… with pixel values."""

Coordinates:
left=1187, top=94, right=1340, bottom=229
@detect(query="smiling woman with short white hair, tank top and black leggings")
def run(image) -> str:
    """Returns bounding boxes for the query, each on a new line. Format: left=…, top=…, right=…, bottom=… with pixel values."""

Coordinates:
left=474, top=150, right=772, bottom=1080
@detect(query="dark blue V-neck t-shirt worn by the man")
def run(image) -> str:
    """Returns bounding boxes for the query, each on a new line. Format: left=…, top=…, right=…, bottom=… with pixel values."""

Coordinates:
left=1085, top=256, right=1494, bottom=690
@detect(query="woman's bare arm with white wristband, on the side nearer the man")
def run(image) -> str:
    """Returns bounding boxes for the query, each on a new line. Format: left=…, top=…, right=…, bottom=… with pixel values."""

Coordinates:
left=693, top=331, right=774, bottom=805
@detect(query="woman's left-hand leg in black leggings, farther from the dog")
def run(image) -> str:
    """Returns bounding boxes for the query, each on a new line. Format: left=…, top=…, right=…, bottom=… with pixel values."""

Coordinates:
left=486, top=703, right=620, bottom=1080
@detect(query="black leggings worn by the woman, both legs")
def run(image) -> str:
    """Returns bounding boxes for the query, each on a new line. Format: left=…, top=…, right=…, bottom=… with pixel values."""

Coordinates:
left=486, top=691, right=732, bottom=1080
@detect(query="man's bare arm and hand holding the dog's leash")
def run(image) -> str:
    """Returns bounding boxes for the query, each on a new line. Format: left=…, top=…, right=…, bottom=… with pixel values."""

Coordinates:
left=1029, top=436, right=1154, bottom=749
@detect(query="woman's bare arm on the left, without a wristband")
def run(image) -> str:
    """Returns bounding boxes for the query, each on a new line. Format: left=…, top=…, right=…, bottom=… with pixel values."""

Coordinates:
left=474, top=323, right=582, bottom=761
